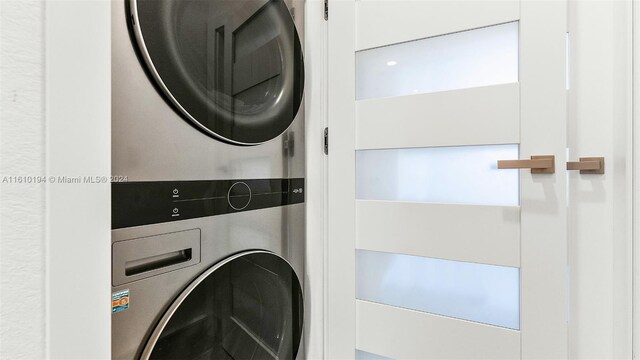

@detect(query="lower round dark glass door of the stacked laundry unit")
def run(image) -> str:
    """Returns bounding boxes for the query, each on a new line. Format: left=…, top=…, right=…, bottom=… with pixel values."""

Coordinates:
left=141, top=251, right=303, bottom=360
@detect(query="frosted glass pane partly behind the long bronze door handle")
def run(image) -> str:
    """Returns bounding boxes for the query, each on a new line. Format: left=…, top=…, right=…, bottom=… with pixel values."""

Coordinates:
left=356, top=144, right=519, bottom=206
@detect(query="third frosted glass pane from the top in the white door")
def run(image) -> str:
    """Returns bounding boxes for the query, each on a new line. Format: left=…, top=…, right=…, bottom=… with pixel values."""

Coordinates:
left=356, top=250, right=520, bottom=329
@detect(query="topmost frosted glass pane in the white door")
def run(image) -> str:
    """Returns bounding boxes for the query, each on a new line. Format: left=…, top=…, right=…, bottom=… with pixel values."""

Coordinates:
left=356, top=22, right=518, bottom=100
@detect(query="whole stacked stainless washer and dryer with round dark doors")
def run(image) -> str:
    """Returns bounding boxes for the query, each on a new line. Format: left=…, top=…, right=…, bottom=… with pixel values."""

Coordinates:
left=112, top=0, right=305, bottom=359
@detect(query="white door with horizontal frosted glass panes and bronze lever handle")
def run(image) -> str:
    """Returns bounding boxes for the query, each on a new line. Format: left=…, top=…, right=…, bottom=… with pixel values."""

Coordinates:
left=325, top=0, right=567, bottom=359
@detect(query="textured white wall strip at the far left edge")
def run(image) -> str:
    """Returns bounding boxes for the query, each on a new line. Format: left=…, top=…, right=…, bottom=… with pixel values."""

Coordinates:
left=0, top=0, right=45, bottom=359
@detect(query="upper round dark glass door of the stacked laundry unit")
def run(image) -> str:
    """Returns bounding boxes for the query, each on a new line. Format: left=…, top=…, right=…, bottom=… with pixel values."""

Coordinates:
left=129, top=0, right=304, bottom=145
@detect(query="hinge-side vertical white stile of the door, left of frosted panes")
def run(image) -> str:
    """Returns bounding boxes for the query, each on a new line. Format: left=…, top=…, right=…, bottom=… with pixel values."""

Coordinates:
left=324, top=0, right=356, bottom=359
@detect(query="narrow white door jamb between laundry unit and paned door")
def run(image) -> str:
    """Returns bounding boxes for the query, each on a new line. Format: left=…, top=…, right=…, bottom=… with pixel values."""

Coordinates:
left=304, top=0, right=327, bottom=360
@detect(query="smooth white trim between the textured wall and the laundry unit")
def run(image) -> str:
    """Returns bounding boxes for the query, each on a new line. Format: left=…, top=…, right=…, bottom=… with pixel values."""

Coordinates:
left=45, top=0, right=111, bottom=359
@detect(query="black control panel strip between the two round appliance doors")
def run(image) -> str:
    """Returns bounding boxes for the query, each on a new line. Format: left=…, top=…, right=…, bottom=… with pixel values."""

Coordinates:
left=111, top=178, right=304, bottom=229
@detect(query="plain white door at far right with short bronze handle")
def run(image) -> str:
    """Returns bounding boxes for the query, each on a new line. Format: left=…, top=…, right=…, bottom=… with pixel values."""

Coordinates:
left=568, top=0, right=633, bottom=359
